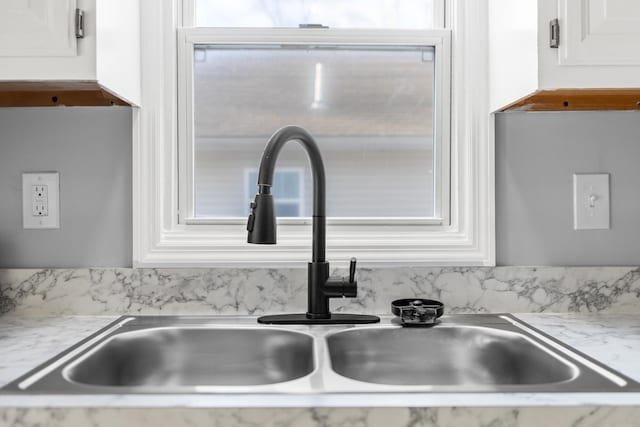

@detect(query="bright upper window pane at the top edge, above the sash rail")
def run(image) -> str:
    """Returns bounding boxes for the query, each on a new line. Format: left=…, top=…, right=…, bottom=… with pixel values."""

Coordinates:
left=196, top=0, right=433, bottom=29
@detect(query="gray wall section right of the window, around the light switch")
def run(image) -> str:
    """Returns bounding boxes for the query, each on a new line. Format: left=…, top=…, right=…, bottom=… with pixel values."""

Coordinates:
left=496, top=111, right=640, bottom=266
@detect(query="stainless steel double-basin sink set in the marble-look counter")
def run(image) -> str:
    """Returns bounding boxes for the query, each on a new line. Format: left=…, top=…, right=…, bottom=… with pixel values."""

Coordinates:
left=5, top=314, right=640, bottom=394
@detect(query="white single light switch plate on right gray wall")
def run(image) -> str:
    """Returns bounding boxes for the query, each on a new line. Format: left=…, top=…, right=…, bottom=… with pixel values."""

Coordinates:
left=573, top=173, right=611, bottom=230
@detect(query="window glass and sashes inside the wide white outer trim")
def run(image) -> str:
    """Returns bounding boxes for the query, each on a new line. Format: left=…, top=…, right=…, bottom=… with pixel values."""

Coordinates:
left=185, top=0, right=449, bottom=224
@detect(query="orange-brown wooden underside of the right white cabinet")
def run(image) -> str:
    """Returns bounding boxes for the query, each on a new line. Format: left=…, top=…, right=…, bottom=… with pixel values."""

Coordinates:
left=500, top=88, right=640, bottom=112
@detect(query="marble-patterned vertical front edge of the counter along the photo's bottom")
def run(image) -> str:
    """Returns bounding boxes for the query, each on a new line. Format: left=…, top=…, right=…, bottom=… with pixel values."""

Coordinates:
left=0, top=406, right=640, bottom=427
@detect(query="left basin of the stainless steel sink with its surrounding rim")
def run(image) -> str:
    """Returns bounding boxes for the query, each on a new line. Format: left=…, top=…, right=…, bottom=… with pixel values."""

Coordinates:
left=5, top=316, right=315, bottom=393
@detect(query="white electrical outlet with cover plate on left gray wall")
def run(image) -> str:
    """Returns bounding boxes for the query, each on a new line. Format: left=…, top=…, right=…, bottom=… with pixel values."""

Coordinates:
left=22, top=172, right=60, bottom=228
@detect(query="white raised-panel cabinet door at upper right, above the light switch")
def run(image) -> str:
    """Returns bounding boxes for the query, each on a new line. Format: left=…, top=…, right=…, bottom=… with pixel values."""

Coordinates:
left=558, top=0, right=640, bottom=65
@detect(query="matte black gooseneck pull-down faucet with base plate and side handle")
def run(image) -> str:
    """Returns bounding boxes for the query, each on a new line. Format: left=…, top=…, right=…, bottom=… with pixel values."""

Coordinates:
left=247, top=126, right=380, bottom=324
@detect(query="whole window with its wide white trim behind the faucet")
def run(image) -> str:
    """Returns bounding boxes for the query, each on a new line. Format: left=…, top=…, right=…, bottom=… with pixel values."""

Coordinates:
left=134, top=0, right=493, bottom=266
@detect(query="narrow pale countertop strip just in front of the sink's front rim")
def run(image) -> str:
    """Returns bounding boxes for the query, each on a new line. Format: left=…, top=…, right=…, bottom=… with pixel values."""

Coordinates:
left=0, top=393, right=640, bottom=410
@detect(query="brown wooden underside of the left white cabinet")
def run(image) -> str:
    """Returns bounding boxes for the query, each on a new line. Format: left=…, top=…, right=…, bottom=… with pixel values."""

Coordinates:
left=0, top=81, right=131, bottom=107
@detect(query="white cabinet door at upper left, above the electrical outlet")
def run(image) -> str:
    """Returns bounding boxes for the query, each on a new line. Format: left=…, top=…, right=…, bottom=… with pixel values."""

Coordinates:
left=0, top=0, right=76, bottom=56
